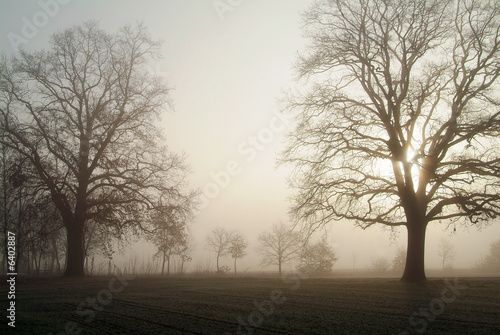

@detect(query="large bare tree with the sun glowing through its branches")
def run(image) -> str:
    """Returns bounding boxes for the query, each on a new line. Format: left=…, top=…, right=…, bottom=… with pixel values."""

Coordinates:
left=282, top=0, right=500, bottom=282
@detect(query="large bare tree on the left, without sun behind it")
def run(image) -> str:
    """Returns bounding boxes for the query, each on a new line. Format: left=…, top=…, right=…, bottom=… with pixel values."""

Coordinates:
left=0, top=22, right=189, bottom=276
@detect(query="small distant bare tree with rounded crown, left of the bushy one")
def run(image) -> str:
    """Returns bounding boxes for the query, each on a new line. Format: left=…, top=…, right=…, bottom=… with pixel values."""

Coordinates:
left=258, top=222, right=302, bottom=275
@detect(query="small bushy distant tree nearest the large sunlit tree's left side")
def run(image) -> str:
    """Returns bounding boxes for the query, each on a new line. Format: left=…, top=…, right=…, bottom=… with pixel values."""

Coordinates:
left=297, top=238, right=337, bottom=274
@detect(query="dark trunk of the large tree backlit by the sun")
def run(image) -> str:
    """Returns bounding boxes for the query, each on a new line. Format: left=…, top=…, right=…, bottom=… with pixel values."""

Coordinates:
left=401, top=221, right=427, bottom=283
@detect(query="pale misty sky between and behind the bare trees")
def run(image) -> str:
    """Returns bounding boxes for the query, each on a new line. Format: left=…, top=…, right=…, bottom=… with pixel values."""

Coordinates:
left=0, top=0, right=500, bottom=270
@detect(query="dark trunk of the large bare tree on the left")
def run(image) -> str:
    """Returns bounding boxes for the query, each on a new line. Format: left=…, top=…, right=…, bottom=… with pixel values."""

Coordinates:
left=64, top=220, right=85, bottom=277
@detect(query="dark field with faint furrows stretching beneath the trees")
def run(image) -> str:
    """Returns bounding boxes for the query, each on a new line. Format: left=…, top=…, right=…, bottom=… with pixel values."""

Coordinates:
left=0, top=275, right=500, bottom=335
